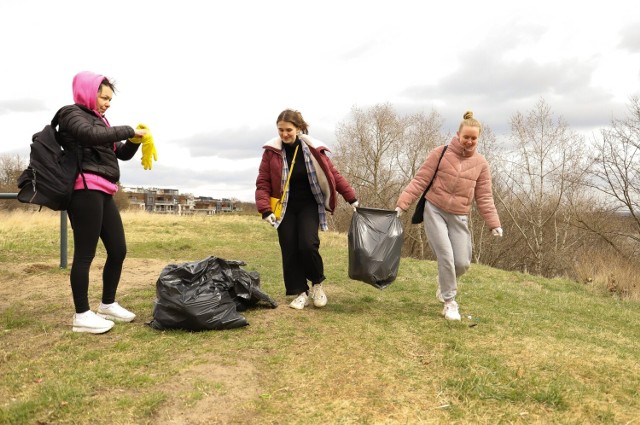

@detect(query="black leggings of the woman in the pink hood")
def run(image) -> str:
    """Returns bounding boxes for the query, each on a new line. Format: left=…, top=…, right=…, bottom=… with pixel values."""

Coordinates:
left=67, top=190, right=127, bottom=313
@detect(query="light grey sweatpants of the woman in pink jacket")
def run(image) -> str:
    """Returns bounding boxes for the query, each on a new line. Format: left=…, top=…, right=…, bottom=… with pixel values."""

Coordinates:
left=424, top=201, right=471, bottom=300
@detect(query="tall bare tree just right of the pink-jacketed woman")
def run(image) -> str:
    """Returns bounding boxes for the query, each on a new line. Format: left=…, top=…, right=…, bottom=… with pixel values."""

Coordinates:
left=496, top=100, right=587, bottom=275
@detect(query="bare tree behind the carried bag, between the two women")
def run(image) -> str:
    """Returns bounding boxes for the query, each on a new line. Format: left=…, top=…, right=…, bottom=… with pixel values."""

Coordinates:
left=334, top=104, right=446, bottom=258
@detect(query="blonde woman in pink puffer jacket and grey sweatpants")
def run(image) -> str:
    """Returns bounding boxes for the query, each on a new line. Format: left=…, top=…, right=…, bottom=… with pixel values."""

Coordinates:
left=396, top=112, right=502, bottom=320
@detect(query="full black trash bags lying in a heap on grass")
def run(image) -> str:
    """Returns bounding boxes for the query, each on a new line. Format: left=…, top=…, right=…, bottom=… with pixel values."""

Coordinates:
left=149, top=256, right=278, bottom=331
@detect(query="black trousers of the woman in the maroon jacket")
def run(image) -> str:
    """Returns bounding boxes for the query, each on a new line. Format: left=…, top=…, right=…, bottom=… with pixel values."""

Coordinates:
left=278, top=201, right=325, bottom=295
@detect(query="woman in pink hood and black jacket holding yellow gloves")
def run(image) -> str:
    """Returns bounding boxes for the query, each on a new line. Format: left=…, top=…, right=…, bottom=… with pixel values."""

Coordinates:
left=57, top=72, right=150, bottom=334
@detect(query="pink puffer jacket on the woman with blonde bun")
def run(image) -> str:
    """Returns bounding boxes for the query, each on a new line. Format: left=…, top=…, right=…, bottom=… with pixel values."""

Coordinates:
left=396, top=137, right=501, bottom=229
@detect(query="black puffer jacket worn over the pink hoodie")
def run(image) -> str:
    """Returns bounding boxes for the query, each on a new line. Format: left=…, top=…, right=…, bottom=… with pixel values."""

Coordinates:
left=58, top=105, right=140, bottom=183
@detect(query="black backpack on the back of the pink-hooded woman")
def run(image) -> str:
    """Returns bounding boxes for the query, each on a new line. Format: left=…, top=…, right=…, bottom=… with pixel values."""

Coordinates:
left=17, top=113, right=86, bottom=211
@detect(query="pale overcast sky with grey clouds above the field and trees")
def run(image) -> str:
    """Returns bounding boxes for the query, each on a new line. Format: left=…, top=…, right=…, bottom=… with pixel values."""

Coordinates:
left=0, top=0, right=640, bottom=202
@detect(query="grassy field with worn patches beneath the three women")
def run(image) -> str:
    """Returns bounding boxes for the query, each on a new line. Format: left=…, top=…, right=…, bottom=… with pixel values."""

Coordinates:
left=0, top=212, right=640, bottom=424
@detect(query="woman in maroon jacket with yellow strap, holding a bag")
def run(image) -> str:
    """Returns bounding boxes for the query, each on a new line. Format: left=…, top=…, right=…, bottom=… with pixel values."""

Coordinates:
left=256, top=109, right=358, bottom=310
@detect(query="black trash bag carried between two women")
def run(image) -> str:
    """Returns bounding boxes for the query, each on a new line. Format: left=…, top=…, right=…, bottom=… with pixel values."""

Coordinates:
left=349, top=207, right=404, bottom=289
